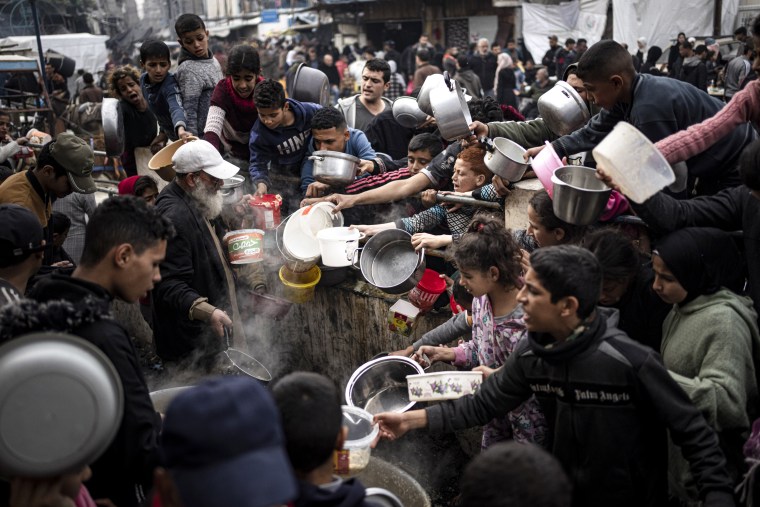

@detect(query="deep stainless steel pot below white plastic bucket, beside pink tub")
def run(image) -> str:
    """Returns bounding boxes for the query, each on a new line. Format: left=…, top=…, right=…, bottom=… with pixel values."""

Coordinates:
left=552, top=165, right=612, bottom=225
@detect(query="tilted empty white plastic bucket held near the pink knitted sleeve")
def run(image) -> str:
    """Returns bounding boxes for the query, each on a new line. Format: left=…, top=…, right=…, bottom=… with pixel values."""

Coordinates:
left=593, top=121, right=676, bottom=204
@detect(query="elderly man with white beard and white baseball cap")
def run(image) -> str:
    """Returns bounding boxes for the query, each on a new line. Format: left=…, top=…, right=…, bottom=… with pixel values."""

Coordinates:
left=153, top=141, right=245, bottom=369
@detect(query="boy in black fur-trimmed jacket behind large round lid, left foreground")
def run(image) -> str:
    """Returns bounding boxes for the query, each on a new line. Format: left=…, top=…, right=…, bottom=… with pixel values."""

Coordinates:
left=0, top=196, right=173, bottom=507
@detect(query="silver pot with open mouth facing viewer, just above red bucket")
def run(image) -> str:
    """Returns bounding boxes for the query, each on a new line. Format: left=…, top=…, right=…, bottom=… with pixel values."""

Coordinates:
left=357, top=229, right=425, bottom=294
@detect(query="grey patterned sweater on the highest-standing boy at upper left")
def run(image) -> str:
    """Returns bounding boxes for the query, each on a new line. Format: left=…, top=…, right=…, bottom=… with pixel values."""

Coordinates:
left=176, top=47, right=224, bottom=136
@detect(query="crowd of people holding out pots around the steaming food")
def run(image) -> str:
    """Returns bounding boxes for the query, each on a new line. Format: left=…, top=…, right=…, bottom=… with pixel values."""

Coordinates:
left=0, top=6, right=760, bottom=507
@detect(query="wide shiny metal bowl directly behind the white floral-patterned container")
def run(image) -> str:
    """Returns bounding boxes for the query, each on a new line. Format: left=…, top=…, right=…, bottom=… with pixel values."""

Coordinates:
left=346, top=356, right=424, bottom=415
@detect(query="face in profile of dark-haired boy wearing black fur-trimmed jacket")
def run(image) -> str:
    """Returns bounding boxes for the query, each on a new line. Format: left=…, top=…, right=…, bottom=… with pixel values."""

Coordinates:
left=114, top=239, right=166, bottom=303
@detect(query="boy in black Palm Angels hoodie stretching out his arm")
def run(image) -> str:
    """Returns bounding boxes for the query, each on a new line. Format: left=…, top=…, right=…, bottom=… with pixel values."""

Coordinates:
left=375, top=246, right=734, bottom=507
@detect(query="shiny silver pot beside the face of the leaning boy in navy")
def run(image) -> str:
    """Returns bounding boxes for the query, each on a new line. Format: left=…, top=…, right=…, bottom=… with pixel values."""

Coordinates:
left=538, top=81, right=591, bottom=136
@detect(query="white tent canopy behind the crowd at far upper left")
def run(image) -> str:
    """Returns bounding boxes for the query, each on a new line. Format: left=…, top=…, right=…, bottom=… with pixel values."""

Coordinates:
left=0, top=33, right=109, bottom=97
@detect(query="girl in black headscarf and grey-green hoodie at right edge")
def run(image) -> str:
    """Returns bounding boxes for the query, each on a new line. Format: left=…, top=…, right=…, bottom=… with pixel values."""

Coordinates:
left=653, top=228, right=760, bottom=501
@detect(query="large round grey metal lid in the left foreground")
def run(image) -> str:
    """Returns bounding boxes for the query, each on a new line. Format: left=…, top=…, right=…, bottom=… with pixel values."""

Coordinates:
left=0, top=333, right=124, bottom=477
